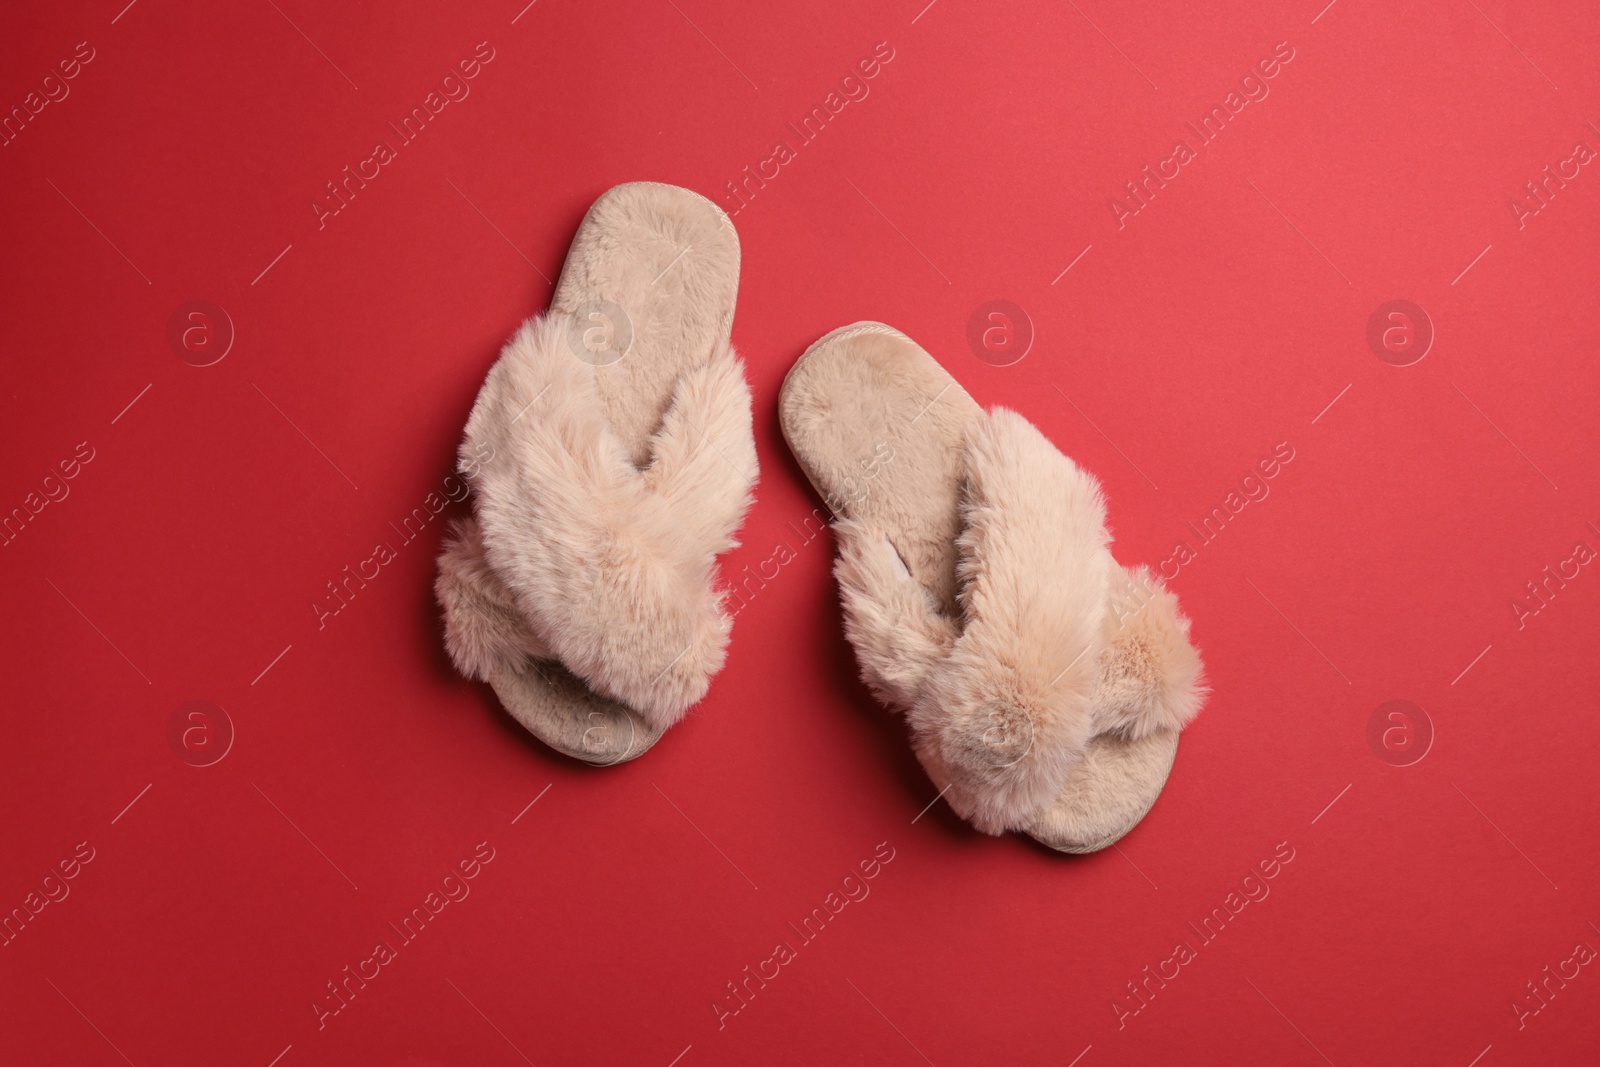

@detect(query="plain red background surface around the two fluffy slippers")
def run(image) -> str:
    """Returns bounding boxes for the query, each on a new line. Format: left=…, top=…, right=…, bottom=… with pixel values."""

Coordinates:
left=0, top=0, right=1600, bottom=1067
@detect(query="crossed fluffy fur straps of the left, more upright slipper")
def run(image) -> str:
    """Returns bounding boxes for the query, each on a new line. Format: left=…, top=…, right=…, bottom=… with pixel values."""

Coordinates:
left=457, top=303, right=757, bottom=728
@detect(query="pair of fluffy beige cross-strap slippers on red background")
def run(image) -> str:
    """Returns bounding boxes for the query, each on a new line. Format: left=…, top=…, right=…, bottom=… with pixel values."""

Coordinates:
left=437, top=182, right=1205, bottom=853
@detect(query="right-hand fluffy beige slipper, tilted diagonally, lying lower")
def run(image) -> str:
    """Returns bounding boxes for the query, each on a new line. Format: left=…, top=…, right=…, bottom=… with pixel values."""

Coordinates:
left=779, top=323, right=1205, bottom=853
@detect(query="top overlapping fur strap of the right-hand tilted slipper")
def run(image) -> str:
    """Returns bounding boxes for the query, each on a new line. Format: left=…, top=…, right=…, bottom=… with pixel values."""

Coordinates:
left=928, top=408, right=1112, bottom=833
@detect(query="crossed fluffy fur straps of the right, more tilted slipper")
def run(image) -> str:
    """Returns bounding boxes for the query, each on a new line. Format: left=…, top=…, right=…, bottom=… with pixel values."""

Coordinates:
left=835, top=408, right=1198, bottom=833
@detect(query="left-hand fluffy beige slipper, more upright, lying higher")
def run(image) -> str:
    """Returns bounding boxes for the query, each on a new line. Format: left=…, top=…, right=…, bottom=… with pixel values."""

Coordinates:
left=435, top=182, right=757, bottom=765
